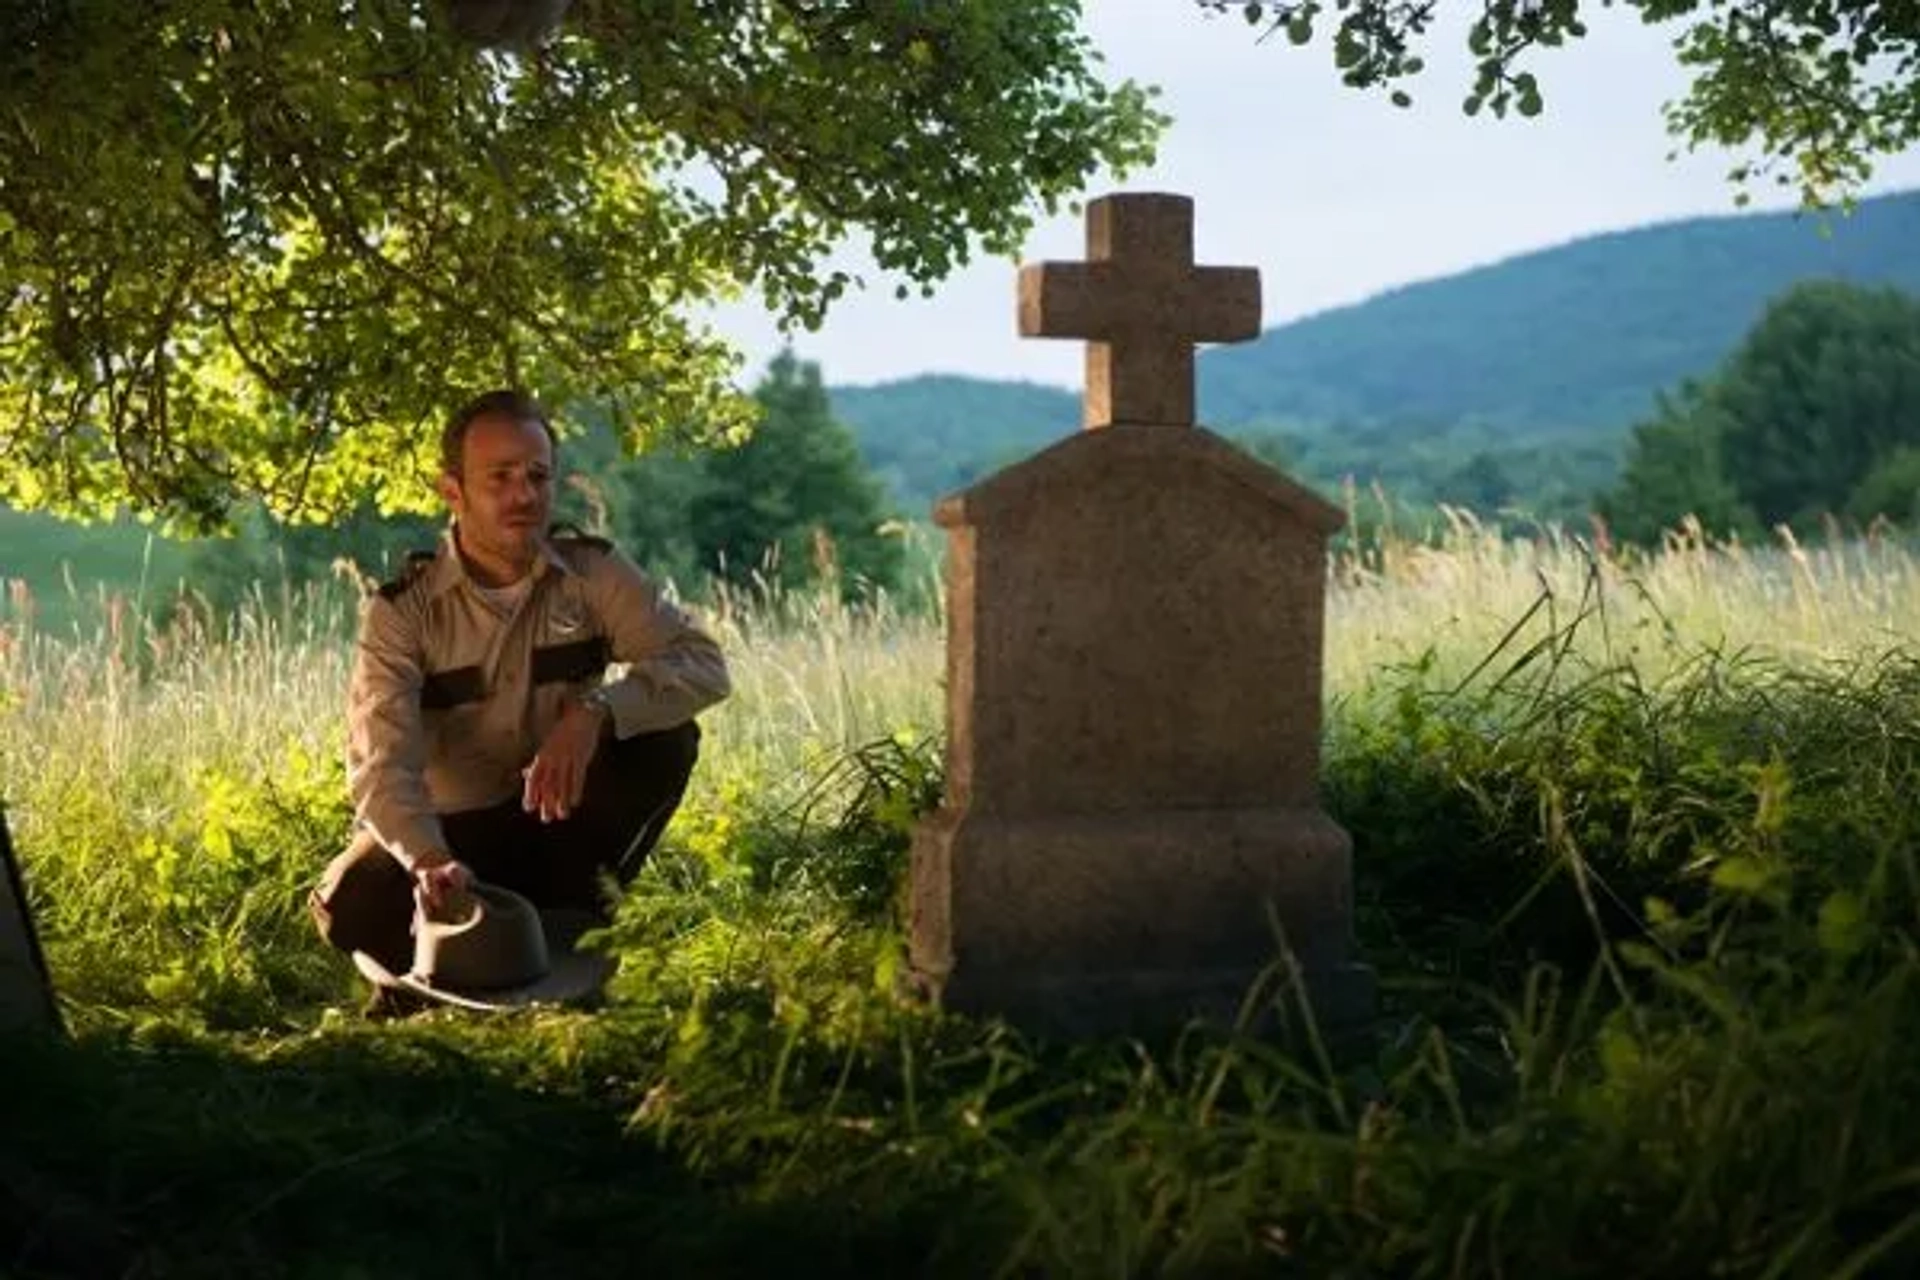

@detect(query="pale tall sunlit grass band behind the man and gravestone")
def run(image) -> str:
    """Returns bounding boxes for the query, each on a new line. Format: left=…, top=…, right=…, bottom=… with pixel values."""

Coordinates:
left=15, top=516, right=1920, bottom=829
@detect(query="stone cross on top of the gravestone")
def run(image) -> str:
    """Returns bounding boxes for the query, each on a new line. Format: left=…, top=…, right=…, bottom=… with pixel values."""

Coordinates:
left=1020, top=194, right=1260, bottom=428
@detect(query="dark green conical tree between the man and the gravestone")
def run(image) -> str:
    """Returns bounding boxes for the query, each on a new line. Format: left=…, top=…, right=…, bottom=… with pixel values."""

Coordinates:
left=689, top=351, right=902, bottom=593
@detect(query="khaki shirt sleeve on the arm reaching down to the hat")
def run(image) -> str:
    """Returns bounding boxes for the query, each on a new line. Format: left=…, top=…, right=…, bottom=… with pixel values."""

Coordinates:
left=348, top=595, right=445, bottom=867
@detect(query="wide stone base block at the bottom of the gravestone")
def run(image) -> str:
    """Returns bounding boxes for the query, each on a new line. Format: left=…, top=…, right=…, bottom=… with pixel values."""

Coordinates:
left=910, top=808, right=1373, bottom=1038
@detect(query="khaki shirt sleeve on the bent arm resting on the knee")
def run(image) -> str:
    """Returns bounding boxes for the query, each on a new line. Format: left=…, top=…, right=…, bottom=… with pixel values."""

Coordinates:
left=588, top=549, right=733, bottom=739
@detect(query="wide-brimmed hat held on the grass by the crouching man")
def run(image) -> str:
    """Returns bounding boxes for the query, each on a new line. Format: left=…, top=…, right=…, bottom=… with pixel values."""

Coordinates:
left=353, top=881, right=616, bottom=1013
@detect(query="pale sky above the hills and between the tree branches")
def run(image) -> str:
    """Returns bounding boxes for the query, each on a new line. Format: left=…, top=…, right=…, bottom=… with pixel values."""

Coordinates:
left=712, top=0, right=1920, bottom=388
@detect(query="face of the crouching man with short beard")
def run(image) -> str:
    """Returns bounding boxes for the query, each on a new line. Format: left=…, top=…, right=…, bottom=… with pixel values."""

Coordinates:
left=440, top=416, right=553, bottom=568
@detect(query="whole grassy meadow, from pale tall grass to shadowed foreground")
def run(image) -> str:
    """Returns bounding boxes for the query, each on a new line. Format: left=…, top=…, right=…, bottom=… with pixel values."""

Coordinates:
left=11, top=516, right=1920, bottom=1276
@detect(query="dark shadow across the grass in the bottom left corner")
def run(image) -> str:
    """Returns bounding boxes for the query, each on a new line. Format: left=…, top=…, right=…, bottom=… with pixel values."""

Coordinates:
left=0, top=1027, right=960, bottom=1280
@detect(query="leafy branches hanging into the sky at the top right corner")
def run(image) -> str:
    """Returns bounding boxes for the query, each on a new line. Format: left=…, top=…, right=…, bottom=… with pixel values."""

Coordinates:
left=1196, top=0, right=1920, bottom=203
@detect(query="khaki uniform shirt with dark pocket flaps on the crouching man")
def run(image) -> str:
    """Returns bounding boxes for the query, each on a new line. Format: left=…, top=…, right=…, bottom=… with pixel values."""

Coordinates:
left=348, top=530, right=730, bottom=865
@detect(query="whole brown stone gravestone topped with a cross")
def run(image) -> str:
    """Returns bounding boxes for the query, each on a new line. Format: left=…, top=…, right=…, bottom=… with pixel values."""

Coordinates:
left=910, top=194, right=1373, bottom=1034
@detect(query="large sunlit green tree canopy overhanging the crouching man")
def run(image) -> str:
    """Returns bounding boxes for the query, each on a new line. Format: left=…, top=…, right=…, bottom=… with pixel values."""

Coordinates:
left=0, top=0, right=1165, bottom=530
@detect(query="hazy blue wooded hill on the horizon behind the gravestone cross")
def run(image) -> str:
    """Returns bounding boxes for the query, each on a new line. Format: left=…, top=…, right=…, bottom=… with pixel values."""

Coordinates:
left=828, top=192, right=1920, bottom=510
